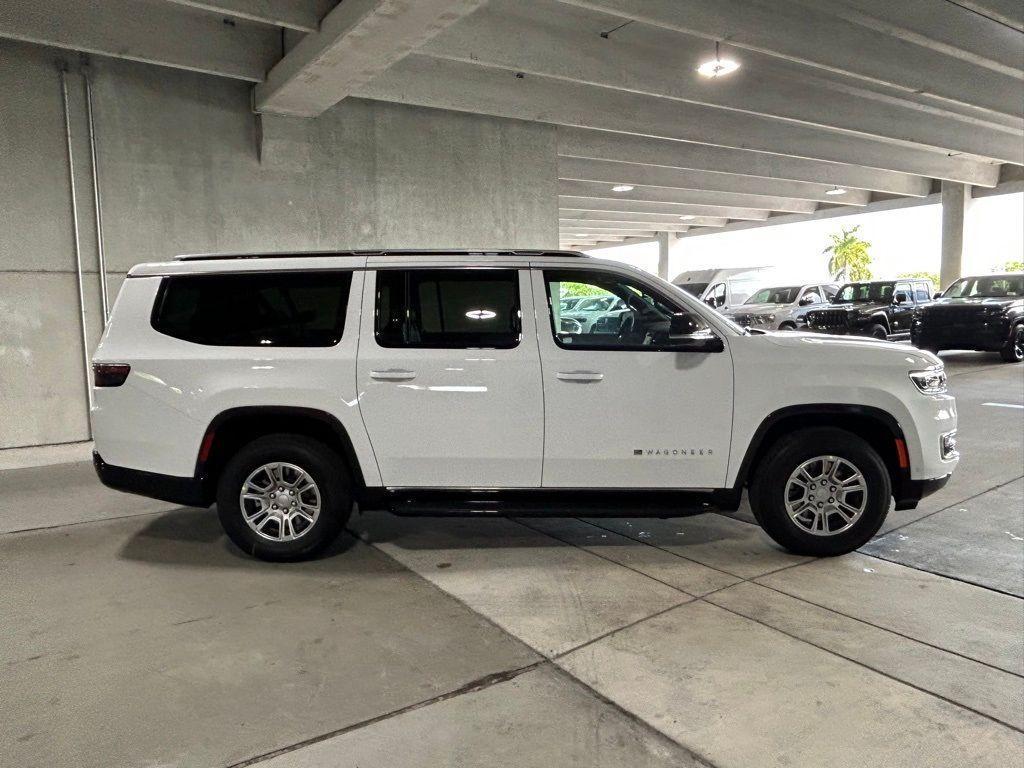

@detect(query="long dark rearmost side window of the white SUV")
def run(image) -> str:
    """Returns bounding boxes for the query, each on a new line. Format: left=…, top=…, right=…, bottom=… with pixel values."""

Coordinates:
left=152, top=271, right=352, bottom=347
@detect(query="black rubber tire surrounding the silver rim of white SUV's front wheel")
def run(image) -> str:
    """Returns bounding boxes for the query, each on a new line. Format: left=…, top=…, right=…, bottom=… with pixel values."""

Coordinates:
left=750, top=427, right=892, bottom=557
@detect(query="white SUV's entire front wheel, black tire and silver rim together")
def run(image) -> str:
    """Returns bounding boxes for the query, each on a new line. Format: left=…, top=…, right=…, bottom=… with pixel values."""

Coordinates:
left=751, top=427, right=892, bottom=556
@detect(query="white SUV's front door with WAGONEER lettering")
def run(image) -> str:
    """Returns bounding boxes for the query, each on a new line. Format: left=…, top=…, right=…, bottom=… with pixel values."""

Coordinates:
left=534, top=266, right=733, bottom=488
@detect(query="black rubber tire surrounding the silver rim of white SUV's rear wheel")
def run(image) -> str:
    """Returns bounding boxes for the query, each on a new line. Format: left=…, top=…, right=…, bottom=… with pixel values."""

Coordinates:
left=217, top=433, right=352, bottom=561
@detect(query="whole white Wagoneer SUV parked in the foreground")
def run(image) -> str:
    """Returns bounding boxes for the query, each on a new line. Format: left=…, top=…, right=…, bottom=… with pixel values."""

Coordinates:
left=92, top=251, right=958, bottom=559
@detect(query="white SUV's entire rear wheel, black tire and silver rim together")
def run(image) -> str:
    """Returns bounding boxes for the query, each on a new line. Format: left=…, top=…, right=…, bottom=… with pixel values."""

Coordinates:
left=217, top=434, right=352, bottom=560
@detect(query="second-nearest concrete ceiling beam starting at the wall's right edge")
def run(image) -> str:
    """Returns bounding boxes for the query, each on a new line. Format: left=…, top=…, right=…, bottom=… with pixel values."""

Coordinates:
left=558, top=158, right=870, bottom=206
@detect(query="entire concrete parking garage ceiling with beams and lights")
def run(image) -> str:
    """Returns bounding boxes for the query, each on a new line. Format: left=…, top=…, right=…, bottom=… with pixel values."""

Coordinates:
left=0, top=0, right=1024, bottom=247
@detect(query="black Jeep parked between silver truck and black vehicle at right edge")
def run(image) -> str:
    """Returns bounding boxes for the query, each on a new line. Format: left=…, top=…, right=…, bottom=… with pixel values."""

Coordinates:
left=807, top=280, right=932, bottom=341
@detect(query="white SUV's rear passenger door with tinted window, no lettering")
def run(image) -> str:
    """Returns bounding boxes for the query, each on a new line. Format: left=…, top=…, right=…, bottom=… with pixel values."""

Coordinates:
left=352, top=268, right=544, bottom=487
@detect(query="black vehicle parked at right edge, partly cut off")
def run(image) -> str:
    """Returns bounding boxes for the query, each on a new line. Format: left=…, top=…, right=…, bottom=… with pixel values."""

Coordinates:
left=910, top=273, right=1024, bottom=362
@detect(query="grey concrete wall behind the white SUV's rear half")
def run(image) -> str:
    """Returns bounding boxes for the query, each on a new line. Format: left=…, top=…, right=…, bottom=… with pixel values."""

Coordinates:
left=0, top=42, right=558, bottom=449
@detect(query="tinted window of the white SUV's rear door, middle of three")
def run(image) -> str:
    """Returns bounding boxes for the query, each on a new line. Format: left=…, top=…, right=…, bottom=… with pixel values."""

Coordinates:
left=375, top=269, right=520, bottom=349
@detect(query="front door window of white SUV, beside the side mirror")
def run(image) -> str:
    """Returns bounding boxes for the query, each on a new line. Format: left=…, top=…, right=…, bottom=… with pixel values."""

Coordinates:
left=544, top=269, right=712, bottom=350
